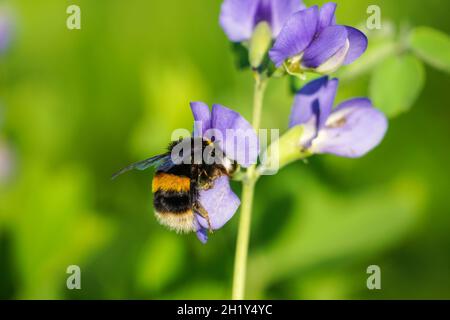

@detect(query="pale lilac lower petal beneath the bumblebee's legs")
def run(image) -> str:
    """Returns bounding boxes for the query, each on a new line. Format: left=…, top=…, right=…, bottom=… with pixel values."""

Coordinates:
left=196, top=176, right=241, bottom=231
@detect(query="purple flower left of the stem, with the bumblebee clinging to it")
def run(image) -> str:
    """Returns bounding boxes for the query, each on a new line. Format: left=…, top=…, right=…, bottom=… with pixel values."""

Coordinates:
left=191, top=102, right=258, bottom=243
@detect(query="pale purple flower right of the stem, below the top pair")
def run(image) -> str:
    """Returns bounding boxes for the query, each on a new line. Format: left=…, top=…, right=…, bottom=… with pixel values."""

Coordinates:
left=289, top=77, right=388, bottom=158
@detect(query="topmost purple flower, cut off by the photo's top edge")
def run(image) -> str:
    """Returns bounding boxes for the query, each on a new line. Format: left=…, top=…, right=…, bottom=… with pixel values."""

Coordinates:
left=220, top=0, right=305, bottom=42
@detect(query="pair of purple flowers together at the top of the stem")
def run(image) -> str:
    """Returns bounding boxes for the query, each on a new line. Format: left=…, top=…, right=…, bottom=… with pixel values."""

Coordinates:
left=220, top=0, right=367, bottom=75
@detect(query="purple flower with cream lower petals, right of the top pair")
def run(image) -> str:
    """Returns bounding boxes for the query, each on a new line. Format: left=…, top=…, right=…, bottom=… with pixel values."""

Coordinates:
left=269, top=2, right=367, bottom=74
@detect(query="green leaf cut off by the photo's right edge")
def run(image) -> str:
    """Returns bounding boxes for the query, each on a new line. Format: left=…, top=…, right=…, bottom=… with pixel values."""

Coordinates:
left=409, top=27, right=450, bottom=73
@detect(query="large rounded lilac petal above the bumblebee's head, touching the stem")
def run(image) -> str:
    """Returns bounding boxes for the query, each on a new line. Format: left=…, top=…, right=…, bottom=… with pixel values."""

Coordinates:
left=211, top=104, right=259, bottom=167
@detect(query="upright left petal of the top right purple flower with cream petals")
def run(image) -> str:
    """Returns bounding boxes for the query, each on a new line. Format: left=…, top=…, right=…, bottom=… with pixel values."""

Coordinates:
left=269, top=6, right=319, bottom=67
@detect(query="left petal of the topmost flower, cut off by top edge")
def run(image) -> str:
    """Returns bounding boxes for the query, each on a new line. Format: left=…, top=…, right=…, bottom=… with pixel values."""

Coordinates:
left=220, top=0, right=260, bottom=42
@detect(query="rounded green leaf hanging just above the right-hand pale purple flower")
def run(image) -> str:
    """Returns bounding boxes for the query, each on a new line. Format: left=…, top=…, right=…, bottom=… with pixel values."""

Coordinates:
left=370, top=54, right=425, bottom=118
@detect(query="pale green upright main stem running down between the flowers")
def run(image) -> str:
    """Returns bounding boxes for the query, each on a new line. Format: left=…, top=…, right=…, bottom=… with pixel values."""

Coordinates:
left=232, top=73, right=267, bottom=300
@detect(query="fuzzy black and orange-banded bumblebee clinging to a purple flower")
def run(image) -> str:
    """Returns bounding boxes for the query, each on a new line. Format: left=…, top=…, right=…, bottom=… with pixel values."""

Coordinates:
left=112, top=137, right=238, bottom=233
